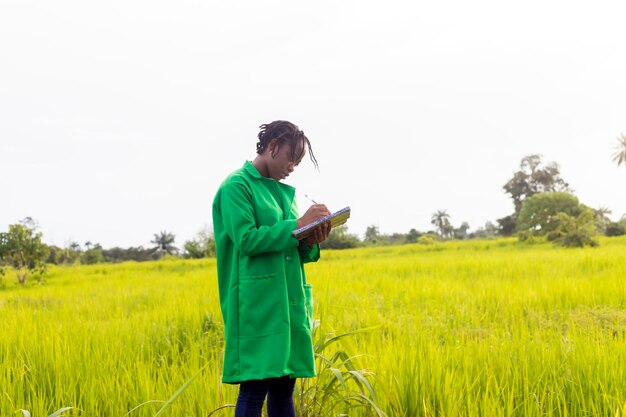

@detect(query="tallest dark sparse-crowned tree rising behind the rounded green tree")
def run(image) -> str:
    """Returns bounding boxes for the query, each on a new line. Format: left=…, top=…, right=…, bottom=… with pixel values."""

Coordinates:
left=503, top=155, right=571, bottom=218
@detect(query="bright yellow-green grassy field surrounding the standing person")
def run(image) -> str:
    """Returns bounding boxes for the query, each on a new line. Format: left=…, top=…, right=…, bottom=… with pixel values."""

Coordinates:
left=0, top=238, right=626, bottom=417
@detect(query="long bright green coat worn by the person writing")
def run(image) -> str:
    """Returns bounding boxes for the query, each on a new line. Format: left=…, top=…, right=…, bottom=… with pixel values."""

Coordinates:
left=213, top=161, right=319, bottom=383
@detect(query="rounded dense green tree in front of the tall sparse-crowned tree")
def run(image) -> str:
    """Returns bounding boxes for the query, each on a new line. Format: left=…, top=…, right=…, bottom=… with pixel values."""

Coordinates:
left=517, top=192, right=583, bottom=236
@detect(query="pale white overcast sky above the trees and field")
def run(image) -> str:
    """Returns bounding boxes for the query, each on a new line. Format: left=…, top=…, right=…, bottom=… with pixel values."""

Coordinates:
left=0, top=0, right=626, bottom=247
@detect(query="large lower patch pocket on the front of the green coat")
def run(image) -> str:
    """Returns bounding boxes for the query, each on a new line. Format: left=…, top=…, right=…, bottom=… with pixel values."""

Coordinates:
left=239, top=274, right=287, bottom=337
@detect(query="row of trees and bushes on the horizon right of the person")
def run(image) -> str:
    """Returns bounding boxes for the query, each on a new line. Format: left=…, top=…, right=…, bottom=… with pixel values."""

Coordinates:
left=322, top=145, right=626, bottom=249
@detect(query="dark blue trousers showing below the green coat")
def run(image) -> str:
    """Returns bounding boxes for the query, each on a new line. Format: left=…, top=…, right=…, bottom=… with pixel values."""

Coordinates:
left=235, top=376, right=296, bottom=417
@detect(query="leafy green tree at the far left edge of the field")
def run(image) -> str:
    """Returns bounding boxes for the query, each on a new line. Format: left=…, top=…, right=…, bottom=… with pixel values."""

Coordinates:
left=0, top=217, right=49, bottom=285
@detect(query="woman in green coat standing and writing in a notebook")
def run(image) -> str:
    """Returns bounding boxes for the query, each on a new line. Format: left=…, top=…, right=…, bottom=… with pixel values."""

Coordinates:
left=213, top=120, right=330, bottom=417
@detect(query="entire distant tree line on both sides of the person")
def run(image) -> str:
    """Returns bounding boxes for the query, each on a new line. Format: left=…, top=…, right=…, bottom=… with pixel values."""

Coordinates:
left=0, top=140, right=626, bottom=286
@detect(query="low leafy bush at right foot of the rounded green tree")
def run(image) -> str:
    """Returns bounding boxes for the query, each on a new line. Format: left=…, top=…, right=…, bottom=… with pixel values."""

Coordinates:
left=547, top=208, right=598, bottom=248
